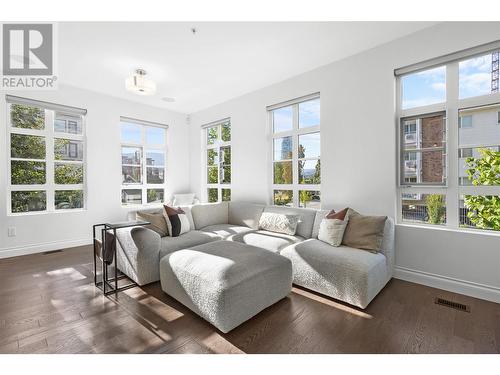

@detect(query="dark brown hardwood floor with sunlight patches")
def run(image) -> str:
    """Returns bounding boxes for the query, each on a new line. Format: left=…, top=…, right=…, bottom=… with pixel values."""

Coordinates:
left=0, top=246, right=500, bottom=353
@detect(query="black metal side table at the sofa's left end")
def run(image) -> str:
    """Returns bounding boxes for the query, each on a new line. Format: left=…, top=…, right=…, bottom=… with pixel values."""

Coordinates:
left=92, top=221, right=151, bottom=295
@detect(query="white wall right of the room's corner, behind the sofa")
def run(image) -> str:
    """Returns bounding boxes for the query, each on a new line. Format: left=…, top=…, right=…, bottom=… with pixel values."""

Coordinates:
left=190, top=23, right=500, bottom=302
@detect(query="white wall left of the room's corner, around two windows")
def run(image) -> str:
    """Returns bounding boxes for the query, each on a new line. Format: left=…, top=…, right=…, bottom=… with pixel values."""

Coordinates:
left=0, top=86, right=189, bottom=258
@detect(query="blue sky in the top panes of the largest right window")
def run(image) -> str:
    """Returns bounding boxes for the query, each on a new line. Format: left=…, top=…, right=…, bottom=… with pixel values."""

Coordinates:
left=401, top=54, right=491, bottom=109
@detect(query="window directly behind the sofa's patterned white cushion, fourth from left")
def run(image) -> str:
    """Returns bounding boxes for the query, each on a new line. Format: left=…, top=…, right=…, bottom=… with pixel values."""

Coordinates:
left=268, top=94, right=321, bottom=208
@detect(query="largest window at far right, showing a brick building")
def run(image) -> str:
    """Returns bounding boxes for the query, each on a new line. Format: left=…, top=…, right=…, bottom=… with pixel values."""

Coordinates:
left=396, top=49, right=500, bottom=231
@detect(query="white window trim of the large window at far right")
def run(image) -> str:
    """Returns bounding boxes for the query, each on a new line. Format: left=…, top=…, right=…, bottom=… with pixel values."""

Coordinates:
left=395, top=54, right=500, bottom=235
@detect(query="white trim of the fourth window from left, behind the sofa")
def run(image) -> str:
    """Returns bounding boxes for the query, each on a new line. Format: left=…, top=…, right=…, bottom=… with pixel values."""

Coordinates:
left=266, top=93, right=322, bottom=207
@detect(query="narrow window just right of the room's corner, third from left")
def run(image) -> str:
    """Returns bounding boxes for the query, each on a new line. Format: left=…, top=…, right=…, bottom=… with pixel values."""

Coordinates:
left=202, top=119, right=231, bottom=203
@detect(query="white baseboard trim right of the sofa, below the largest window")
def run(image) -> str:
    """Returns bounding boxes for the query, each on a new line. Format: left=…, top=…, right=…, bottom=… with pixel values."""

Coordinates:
left=394, top=266, right=500, bottom=303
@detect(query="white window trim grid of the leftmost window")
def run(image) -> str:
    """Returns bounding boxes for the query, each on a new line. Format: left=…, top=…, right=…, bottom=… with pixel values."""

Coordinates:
left=6, top=95, right=87, bottom=216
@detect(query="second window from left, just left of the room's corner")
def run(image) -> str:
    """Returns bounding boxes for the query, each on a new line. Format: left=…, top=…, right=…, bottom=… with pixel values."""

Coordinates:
left=120, top=117, right=168, bottom=205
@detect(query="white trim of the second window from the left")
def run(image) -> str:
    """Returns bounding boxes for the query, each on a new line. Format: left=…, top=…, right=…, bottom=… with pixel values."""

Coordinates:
left=119, top=117, right=168, bottom=208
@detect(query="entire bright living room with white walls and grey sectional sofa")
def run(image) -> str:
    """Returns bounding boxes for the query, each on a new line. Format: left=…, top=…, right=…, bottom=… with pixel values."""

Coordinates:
left=0, top=2, right=500, bottom=371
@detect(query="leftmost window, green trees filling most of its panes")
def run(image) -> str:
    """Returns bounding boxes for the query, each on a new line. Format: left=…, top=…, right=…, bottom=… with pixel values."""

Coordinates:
left=6, top=95, right=86, bottom=214
